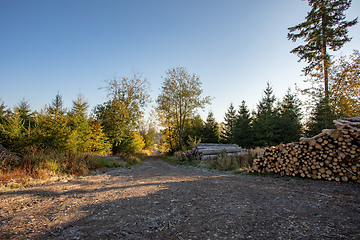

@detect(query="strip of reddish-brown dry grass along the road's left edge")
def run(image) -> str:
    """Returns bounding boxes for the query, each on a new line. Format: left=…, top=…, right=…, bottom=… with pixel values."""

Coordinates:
left=0, top=149, right=146, bottom=191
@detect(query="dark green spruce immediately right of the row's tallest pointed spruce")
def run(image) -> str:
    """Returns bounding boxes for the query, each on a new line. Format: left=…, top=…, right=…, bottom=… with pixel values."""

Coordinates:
left=279, top=88, right=302, bottom=143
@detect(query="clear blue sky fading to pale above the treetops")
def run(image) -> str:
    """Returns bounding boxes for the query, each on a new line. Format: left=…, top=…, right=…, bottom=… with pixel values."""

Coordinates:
left=0, top=0, right=360, bottom=122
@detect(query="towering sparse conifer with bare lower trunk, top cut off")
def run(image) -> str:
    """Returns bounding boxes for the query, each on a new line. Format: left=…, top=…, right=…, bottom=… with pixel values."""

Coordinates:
left=288, top=0, right=357, bottom=99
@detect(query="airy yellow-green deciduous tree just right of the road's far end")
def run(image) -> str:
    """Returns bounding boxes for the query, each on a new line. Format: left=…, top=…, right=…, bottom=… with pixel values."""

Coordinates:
left=156, top=67, right=210, bottom=151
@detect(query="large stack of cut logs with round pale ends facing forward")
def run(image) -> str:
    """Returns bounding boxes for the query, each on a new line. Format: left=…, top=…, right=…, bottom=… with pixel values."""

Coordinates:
left=250, top=116, right=360, bottom=183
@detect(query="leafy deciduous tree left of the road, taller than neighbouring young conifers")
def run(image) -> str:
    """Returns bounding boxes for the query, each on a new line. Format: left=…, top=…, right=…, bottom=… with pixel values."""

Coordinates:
left=94, top=73, right=150, bottom=153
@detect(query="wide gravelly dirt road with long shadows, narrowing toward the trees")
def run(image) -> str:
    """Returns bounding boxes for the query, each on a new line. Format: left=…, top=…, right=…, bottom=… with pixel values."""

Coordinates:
left=0, top=158, right=360, bottom=240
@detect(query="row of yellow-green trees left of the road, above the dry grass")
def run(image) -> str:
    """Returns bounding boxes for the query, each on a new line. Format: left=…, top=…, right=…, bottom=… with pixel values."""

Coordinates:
left=0, top=73, right=155, bottom=154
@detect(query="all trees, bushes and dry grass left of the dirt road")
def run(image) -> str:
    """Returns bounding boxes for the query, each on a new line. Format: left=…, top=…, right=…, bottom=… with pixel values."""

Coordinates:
left=0, top=73, right=155, bottom=188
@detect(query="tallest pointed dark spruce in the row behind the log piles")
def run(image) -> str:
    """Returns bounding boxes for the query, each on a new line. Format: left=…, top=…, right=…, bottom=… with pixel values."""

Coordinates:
left=253, top=83, right=281, bottom=146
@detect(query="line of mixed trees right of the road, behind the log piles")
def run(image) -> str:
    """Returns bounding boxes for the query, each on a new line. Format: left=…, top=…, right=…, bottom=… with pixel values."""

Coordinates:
left=156, top=50, right=360, bottom=152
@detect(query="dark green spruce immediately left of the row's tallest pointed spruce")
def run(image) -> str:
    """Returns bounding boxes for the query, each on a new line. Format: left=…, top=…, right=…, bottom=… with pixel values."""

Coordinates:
left=232, top=101, right=254, bottom=148
